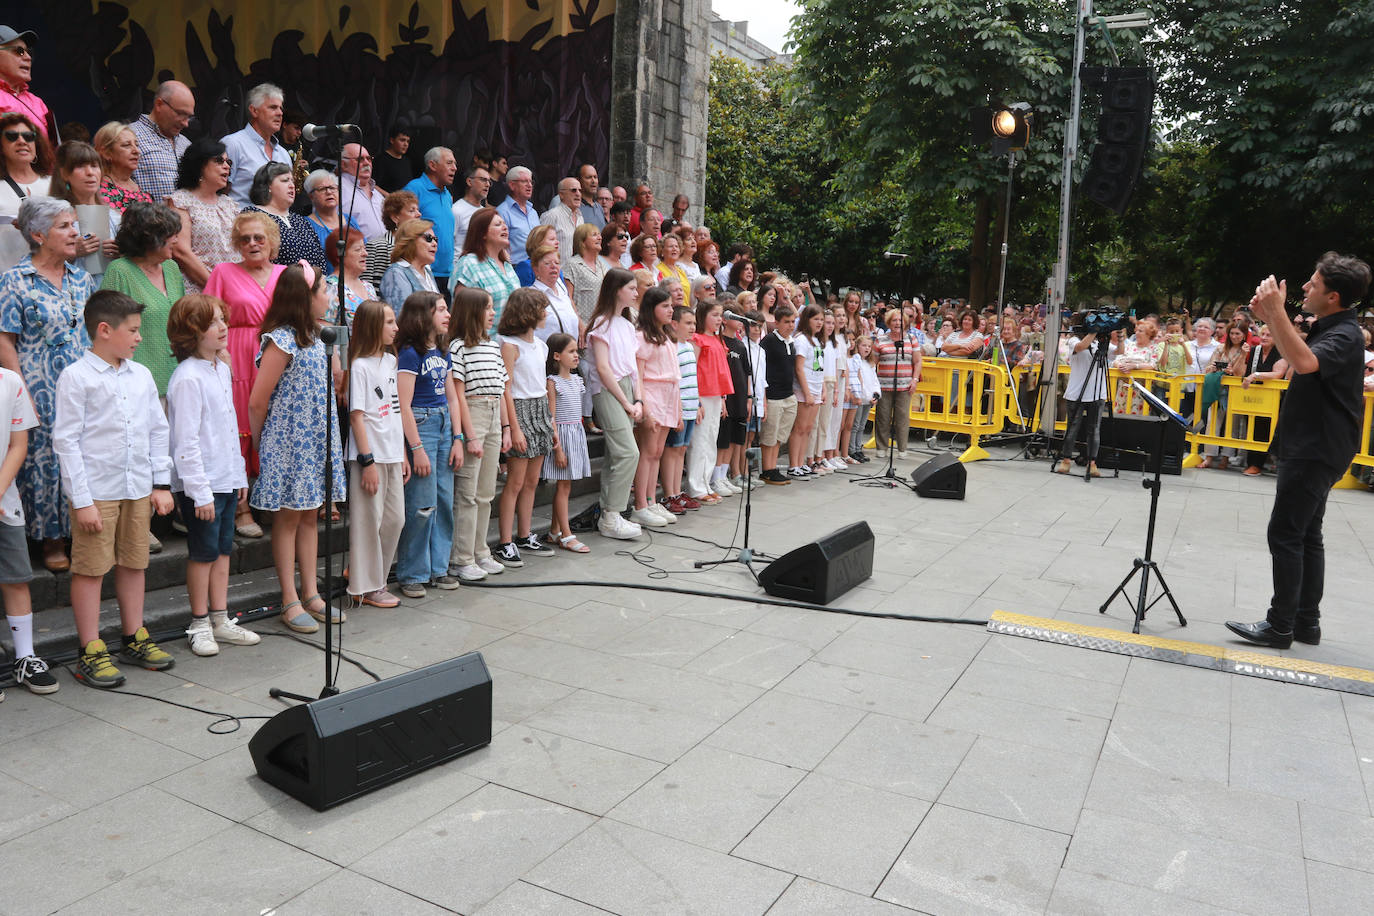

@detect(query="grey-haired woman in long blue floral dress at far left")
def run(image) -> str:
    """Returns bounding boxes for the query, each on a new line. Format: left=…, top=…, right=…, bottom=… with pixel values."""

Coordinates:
left=0, top=196, right=95, bottom=571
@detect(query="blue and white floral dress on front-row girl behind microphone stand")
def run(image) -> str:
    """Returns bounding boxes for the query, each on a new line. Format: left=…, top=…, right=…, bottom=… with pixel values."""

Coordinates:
left=250, top=328, right=344, bottom=511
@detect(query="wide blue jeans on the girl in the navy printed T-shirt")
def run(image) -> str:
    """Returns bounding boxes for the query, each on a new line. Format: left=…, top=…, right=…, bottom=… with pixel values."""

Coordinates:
left=396, top=407, right=453, bottom=585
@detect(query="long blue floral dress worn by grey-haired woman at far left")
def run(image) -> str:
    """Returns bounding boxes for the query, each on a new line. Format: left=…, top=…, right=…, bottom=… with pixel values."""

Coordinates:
left=0, top=255, right=95, bottom=540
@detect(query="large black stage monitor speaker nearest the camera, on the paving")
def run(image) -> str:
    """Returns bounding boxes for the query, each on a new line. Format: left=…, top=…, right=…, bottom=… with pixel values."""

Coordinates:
left=249, top=652, right=492, bottom=812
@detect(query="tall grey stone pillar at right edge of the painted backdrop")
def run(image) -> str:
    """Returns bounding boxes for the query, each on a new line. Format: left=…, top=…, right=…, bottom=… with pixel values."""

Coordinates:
left=603, top=0, right=710, bottom=222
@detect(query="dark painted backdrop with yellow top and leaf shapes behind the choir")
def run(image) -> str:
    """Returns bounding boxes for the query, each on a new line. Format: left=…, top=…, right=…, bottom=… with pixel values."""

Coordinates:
left=0, top=0, right=616, bottom=202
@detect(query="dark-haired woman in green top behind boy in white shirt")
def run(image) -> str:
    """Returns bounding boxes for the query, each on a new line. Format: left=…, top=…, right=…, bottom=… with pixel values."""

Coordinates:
left=100, top=202, right=185, bottom=397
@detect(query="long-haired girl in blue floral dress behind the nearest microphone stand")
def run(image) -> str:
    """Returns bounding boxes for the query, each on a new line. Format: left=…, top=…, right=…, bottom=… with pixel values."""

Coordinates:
left=249, top=262, right=345, bottom=633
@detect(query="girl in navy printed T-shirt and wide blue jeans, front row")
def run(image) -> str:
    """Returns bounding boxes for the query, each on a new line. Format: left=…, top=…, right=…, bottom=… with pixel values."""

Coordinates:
left=396, top=291, right=463, bottom=597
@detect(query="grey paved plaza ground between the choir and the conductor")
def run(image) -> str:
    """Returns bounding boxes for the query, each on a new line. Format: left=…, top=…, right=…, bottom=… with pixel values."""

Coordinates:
left=0, top=442, right=1374, bottom=916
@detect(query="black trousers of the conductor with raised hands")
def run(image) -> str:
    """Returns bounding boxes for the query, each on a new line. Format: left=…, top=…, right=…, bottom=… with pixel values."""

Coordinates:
left=1267, top=459, right=1344, bottom=633
